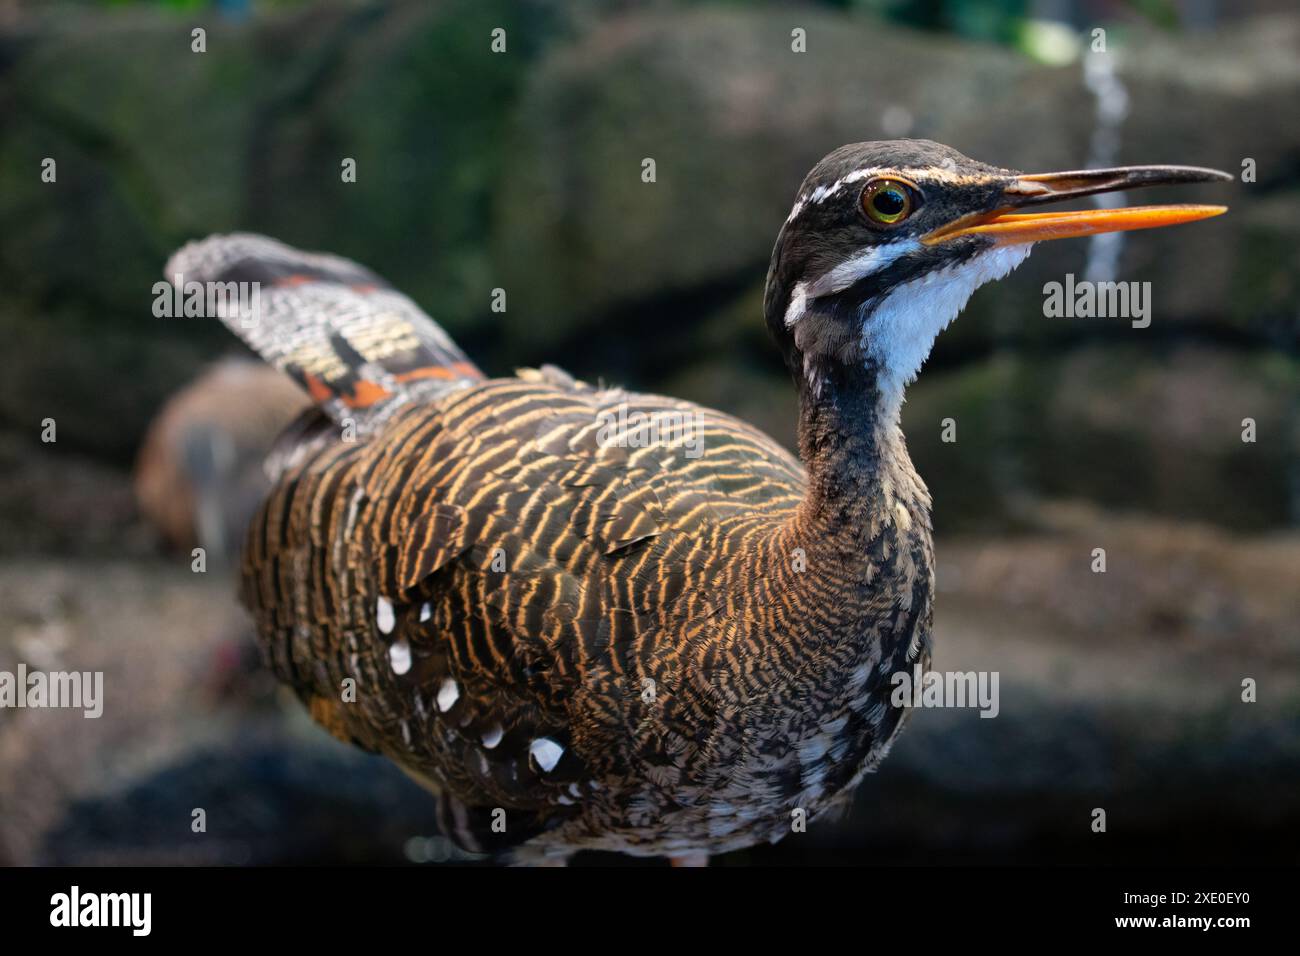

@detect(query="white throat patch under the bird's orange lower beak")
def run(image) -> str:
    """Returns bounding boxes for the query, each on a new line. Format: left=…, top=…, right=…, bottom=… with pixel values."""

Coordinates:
left=862, top=243, right=1032, bottom=418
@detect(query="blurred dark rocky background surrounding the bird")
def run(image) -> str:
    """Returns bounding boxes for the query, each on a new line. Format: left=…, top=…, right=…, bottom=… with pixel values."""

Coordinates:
left=0, top=0, right=1300, bottom=864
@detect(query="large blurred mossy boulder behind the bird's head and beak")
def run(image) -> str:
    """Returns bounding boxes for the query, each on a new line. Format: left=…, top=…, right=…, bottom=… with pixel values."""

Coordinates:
left=497, top=8, right=1300, bottom=354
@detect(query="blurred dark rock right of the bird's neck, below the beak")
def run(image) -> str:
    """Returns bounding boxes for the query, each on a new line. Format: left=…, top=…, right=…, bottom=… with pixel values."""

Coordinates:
left=902, top=345, right=1300, bottom=532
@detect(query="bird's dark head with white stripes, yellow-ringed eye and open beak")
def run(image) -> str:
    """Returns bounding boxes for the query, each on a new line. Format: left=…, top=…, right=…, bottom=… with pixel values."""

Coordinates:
left=764, top=139, right=1231, bottom=407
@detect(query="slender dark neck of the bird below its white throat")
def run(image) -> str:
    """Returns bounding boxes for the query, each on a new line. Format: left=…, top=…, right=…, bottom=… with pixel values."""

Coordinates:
left=798, top=362, right=930, bottom=549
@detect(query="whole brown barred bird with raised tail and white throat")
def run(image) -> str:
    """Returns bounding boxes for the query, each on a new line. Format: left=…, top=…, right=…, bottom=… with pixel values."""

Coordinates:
left=168, top=140, right=1227, bottom=860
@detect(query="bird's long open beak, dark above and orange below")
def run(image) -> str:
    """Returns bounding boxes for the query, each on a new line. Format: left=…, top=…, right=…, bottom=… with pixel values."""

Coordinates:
left=922, top=166, right=1232, bottom=246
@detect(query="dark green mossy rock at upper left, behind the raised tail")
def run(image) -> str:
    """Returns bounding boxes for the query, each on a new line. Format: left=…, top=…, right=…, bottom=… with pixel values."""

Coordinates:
left=0, top=0, right=558, bottom=464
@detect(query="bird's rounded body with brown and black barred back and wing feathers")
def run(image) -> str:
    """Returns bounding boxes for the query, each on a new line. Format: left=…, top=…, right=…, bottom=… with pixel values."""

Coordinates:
left=244, top=372, right=928, bottom=852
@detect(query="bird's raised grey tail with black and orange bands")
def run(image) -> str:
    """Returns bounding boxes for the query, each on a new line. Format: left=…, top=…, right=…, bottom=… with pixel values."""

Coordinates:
left=166, top=233, right=484, bottom=431
